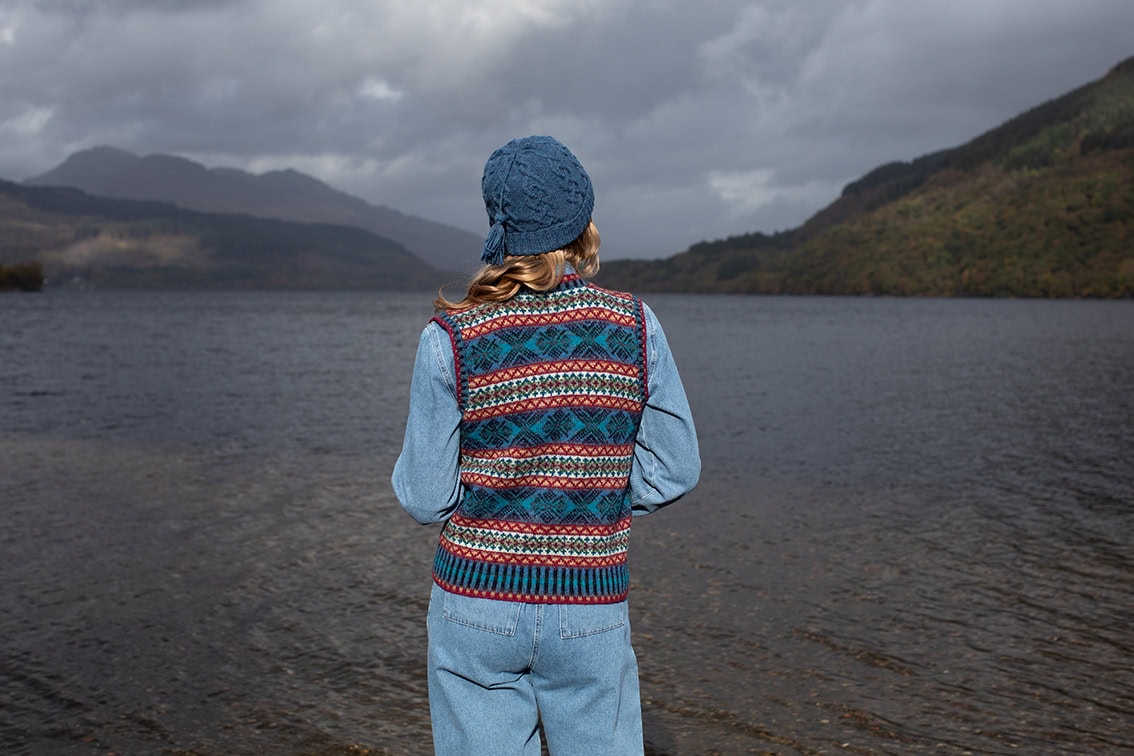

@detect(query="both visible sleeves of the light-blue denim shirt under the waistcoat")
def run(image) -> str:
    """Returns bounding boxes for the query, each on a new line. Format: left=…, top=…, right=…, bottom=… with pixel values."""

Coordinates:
left=392, top=303, right=701, bottom=524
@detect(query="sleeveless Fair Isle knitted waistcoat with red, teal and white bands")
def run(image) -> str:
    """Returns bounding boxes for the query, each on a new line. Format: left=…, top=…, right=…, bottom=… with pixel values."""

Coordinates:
left=433, top=273, right=646, bottom=604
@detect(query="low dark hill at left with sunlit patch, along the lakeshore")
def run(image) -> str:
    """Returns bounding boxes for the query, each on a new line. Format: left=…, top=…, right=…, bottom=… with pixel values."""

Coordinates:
left=0, top=180, right=450, bottom=290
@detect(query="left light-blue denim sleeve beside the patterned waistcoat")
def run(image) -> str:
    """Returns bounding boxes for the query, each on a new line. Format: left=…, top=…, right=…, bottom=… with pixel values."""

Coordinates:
left=391, top=322, right=460, bottom=525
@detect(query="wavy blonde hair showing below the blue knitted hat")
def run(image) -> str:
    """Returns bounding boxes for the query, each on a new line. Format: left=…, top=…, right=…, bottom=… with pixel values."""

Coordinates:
left=433, top=221, right=602, bottom=311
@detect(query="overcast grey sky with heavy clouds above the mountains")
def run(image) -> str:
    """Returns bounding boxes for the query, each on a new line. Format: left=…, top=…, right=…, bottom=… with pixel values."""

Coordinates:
left=0, top=0, right=1134, bottom=258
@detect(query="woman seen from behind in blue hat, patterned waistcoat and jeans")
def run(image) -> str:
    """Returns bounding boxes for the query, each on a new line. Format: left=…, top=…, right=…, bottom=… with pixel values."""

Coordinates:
left=392, top=136, right=701, bottom=756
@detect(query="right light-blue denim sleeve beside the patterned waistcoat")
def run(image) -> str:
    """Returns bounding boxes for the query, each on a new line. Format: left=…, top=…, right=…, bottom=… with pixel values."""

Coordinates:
left=631, top=304, right=701, bottom=516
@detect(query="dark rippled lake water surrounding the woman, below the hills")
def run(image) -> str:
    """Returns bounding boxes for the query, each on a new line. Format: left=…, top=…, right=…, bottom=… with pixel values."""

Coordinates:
left=0, top=291, right=1134, bottom=755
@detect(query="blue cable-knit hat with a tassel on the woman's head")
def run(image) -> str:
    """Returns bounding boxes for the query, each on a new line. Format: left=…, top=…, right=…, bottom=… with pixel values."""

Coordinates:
left=481, top=136, right=594, bottom=265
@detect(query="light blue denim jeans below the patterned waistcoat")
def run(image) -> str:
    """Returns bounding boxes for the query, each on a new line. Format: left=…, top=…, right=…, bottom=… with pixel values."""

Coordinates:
left=429, top=584, right=643, bottom=756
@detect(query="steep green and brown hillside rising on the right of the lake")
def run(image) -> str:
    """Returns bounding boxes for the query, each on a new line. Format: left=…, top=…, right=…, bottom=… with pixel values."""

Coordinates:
left=599, top=58, right=1134, bottom=297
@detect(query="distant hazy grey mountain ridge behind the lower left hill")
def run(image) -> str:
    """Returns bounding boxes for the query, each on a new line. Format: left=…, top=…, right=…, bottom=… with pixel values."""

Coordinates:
left=25, top=147, right=484, bottom=272
